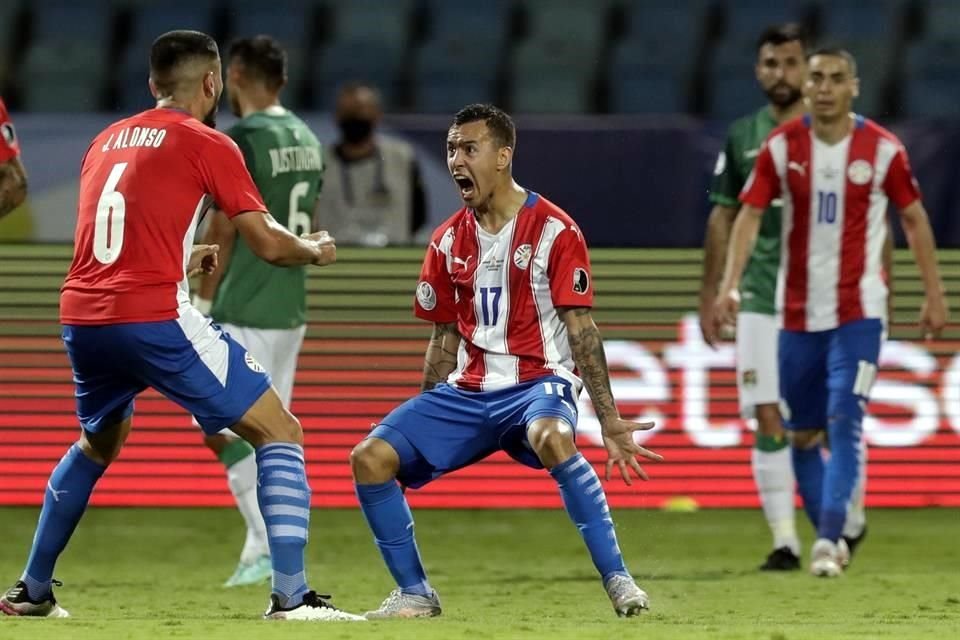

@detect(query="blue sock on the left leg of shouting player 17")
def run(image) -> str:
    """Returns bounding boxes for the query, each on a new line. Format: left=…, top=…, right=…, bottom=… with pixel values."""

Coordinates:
left=356, top=480, right=433, bottom=596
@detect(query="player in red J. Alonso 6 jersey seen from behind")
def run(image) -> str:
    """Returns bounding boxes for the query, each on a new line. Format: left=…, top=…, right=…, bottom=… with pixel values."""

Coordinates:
left=0, top=31, right=362, bottom=620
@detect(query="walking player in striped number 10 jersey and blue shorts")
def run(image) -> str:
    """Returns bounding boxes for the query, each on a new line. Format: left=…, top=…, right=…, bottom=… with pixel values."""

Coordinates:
left=715, top=49, right=947, bottom=577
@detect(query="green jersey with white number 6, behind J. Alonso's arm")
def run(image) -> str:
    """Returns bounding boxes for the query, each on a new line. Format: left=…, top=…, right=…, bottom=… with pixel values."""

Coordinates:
left=210, top=106, right=324, bottom=329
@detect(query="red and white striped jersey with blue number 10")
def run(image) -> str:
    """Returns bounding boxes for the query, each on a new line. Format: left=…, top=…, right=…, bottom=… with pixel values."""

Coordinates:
left=740, top=116, right=920, bottom=331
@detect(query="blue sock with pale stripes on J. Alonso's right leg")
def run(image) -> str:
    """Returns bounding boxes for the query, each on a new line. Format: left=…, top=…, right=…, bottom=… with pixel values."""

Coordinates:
left=257, top=442, right=310, bottom=608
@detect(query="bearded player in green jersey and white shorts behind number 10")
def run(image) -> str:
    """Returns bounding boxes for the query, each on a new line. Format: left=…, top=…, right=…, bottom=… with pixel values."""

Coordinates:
left=700, top=24, right=806, bottom=571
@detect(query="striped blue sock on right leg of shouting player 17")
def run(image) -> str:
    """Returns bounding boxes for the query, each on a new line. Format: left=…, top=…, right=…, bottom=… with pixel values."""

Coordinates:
left=550, top=453, right=630, bottom=584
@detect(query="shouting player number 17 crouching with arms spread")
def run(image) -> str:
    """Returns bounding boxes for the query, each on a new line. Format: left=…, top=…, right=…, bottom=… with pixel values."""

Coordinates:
left=351, top=104, right=661, bottom=618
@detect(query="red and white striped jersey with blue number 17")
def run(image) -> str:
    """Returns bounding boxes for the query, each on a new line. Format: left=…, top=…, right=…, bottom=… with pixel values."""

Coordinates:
left=414, top=192, right=593, bottom=390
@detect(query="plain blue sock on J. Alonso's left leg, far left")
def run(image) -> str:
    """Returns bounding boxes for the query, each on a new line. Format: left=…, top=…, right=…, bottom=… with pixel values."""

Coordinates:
left=20, top=445, right=106, bottom=600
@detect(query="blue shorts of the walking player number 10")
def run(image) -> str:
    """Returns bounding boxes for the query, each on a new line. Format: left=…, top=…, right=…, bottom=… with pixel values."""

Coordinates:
left=778, top=318, right=883, bottom=430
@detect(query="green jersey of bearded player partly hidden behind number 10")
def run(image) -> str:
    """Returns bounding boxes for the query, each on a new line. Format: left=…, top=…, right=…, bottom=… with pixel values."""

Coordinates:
left=710, top=107, right=780, bottom=315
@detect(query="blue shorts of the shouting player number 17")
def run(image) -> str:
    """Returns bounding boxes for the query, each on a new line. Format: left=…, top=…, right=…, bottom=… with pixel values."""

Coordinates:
left=367, top=376, right=579, bottom=489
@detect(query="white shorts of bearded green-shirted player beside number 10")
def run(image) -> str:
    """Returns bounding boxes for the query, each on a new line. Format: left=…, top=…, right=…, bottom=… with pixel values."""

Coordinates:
left=737, top=311, right=780, bottom=420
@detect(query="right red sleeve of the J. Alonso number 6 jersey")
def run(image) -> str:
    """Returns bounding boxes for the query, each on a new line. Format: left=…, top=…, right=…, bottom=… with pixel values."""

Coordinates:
left=200, top=136, right=267, bottom=218
